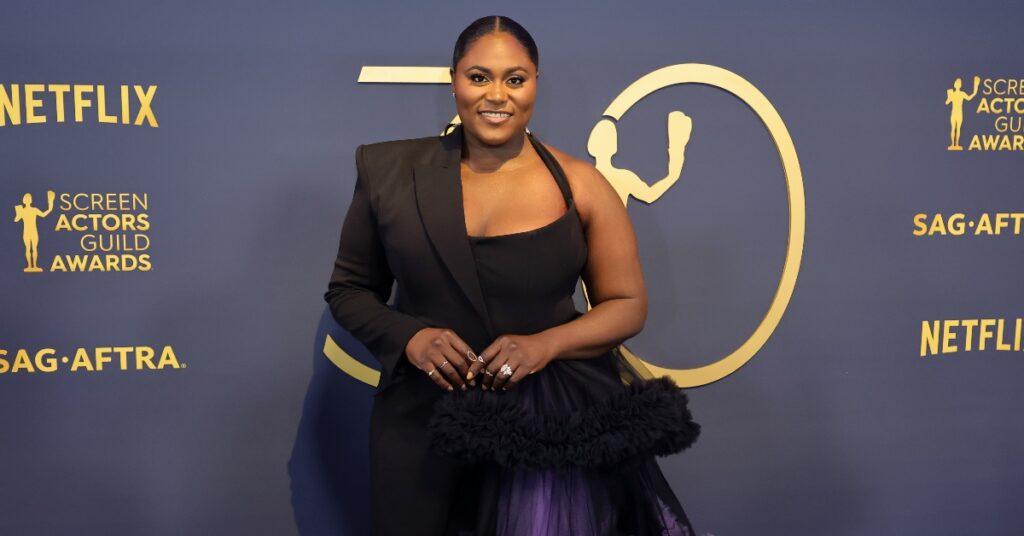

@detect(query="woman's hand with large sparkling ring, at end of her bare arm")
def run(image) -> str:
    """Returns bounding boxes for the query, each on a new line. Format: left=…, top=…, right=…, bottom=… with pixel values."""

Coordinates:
left=480, top=333, right=555, bottom=390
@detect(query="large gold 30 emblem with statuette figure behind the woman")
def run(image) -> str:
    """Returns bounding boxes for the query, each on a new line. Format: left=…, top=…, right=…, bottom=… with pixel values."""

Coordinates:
left=324, top=64, right=806, bottom=387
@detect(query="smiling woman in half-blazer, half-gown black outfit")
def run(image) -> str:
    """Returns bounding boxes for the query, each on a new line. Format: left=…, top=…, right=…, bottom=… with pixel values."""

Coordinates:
left=325, top=16, right=699, bottom=536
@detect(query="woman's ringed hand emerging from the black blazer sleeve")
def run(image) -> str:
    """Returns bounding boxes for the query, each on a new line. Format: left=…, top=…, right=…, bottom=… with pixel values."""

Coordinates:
left=406, top=328, right=473, bottom=390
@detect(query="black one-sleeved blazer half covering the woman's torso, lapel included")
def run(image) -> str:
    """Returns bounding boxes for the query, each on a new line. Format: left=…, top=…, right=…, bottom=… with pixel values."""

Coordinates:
left=324, top=125, right=496, bottom=396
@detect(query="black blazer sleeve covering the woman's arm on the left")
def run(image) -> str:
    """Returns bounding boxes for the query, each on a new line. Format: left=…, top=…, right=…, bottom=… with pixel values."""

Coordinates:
left=324, top=146, right=429, bottom=391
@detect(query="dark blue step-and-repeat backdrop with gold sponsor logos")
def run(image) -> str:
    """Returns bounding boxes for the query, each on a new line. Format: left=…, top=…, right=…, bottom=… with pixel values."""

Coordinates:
left=0, top=1, right=1024, bottom=535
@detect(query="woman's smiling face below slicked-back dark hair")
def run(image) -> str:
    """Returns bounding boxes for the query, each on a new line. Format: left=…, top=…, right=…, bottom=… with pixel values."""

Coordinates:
left=452, top=32, right=537, bottom=146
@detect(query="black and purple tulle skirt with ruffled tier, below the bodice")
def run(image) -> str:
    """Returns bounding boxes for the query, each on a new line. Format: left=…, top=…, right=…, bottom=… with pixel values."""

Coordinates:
left=429, top=351, right=700, bottom=536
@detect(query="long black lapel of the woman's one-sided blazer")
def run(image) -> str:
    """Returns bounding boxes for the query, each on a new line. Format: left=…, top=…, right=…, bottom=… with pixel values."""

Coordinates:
left=414, top=124, right=495, bottom=337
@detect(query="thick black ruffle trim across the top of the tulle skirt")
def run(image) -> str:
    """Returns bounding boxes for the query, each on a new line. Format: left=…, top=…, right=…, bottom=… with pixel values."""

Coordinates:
left=428, top=378, right=700, bottom=468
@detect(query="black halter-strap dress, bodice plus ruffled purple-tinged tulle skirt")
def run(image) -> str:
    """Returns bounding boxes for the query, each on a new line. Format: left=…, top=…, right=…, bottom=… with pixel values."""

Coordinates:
left=428, top=134, right=700, bottom=536
